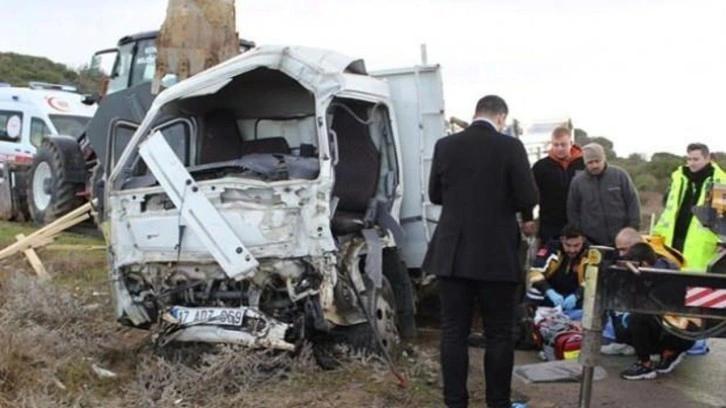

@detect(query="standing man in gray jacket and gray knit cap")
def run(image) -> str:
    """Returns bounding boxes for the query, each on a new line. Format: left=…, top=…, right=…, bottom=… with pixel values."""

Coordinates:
left=567, top=143, right=640, bottom=246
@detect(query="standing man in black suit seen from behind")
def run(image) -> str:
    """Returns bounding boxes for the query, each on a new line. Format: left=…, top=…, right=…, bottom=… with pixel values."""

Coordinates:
left=423, top=95, right=537, bottom=408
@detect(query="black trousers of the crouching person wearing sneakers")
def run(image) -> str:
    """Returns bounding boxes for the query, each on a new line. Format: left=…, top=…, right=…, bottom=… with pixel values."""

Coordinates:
left=628, top=313, right=695, bottom=361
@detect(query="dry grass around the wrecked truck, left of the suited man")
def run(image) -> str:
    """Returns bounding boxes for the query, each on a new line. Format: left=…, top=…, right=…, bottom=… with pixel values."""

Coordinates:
left=0, top=224, right=441, bottom=408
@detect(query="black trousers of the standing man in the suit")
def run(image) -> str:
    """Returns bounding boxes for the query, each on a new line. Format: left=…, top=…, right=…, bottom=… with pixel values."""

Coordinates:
left=439, top=277, right=517, bottom=408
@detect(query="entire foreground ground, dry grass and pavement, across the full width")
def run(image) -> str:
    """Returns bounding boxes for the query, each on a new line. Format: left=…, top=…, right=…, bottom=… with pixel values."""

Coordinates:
left=0, top=220, right=726, bottom=408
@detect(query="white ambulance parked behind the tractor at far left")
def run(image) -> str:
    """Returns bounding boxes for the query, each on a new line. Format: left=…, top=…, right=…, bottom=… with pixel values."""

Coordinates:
left=0, top=82, right=96, bottom=166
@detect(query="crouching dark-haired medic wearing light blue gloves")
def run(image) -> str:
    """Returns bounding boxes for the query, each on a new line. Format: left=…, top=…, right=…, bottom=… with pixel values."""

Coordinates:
left=526, top=226, right=589, bottom=311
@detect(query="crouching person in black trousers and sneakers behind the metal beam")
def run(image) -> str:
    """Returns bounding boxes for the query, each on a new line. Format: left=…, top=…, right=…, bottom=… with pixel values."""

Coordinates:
left=620, top=242, right=700, bottom=380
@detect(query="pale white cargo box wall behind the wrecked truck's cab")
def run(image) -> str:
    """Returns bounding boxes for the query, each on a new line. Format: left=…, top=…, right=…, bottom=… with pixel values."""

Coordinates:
left=370, top=65, right=446, bottom=268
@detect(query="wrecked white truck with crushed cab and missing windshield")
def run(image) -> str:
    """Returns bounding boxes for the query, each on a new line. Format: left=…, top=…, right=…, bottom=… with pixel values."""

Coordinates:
left=99, top=47, right=446, bottom=356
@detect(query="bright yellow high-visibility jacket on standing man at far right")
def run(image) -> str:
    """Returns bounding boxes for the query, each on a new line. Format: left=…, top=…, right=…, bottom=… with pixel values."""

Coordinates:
left=653, top=161, right=726, bottom=272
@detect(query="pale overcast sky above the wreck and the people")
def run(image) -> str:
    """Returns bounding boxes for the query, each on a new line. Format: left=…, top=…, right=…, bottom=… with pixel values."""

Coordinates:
left=0, top=0, right=726, bottom=156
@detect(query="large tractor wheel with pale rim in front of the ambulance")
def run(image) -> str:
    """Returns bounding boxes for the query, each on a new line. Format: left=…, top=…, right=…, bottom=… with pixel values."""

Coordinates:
left=27, top=138, right=85, bottom=225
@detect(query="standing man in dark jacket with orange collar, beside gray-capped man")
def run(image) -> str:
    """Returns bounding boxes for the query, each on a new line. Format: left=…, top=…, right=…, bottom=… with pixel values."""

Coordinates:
left=522, top=126, right=585, bottom=247
